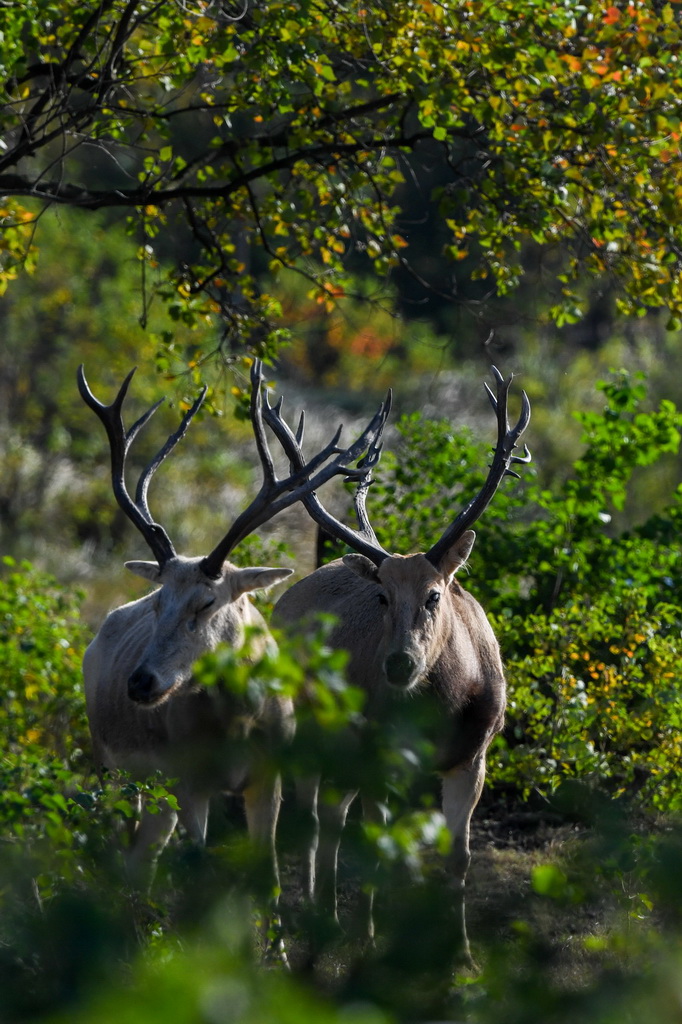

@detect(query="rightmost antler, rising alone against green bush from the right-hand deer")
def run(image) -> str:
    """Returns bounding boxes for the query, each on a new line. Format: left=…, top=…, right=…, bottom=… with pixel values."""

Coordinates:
left=426, top=367, right=530, bottom=568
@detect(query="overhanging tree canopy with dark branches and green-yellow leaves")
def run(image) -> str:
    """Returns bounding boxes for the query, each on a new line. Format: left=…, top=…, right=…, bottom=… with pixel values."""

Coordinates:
left=0, top=0, right=682, bottom=351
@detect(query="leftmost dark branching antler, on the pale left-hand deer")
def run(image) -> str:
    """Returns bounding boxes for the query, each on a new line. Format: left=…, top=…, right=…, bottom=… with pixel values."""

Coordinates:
left=78, top=364, right=206, bottom=566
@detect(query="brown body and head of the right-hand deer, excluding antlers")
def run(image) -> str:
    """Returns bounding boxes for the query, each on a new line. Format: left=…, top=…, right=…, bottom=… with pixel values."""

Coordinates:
left=272, top=530, right=506, bottom=948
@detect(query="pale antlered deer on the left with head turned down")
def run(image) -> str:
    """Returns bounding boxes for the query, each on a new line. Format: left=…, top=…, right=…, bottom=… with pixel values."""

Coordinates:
left=78, top=360, right=386, bottom=913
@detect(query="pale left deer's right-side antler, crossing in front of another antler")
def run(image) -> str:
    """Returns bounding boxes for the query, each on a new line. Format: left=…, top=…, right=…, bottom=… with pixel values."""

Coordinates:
left=202, top=359, right=390, bottom=578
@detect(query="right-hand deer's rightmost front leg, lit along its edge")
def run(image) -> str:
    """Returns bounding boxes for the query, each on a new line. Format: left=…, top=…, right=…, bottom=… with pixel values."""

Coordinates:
left=442, top=751, right=485, bottom=961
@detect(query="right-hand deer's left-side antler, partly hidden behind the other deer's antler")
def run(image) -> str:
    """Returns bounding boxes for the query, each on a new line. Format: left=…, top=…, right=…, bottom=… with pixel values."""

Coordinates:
left=258, top=391, right=391, bottom=565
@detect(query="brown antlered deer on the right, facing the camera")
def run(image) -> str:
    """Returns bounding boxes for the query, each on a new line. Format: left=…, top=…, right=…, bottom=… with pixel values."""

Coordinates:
left=264, top=367, right=530, bottom=963
